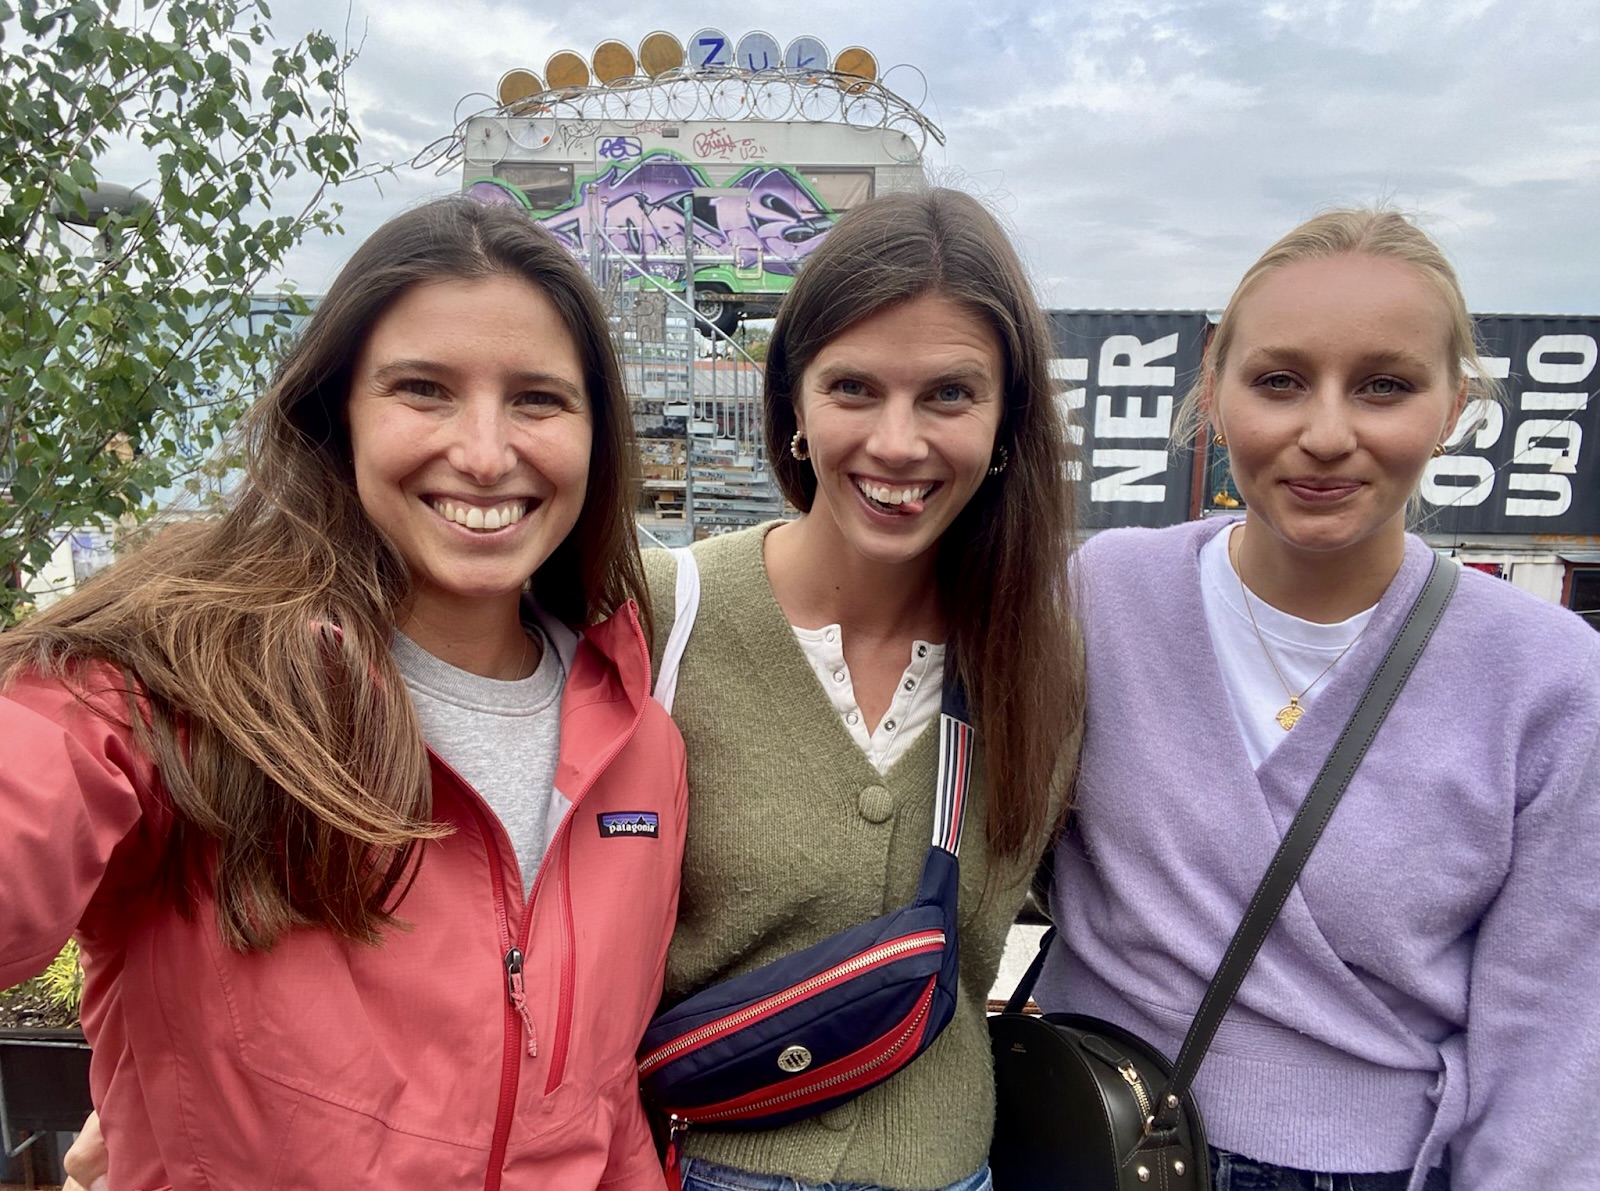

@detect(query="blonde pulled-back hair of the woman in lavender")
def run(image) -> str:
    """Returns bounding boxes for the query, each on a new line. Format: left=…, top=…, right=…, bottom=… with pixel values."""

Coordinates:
left=1171, top=207, right=1502, bottom=448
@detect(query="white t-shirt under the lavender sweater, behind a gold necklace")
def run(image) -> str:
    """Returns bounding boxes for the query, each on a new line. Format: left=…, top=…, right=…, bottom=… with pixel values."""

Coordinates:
left=1200, top=530, right=1376, bottom=768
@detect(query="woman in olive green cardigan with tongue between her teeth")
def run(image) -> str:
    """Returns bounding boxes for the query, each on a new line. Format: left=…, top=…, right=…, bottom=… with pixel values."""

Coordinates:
left=646, top=190, right=1082, bottom=1191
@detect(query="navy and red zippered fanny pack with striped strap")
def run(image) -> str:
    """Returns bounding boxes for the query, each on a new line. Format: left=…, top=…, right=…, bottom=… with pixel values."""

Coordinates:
left=638, top=551, right=974, bottom=1178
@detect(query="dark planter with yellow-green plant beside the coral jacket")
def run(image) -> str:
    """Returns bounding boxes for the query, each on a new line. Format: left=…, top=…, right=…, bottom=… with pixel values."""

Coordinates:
left=0, top=941, right=91, bottom=1185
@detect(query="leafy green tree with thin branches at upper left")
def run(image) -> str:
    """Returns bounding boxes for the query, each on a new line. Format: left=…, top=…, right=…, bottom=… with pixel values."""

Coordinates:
left=0, top=0, right=381, bottom=624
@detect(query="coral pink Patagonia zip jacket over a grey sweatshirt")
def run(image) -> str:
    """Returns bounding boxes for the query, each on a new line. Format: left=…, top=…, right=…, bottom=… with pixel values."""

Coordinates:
left=0, top=605, right=686, bottom=1191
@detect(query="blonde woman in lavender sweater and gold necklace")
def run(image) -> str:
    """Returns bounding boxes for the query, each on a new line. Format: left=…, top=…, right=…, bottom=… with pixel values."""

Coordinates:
left=1038, top=211, right=1600, bottom=1191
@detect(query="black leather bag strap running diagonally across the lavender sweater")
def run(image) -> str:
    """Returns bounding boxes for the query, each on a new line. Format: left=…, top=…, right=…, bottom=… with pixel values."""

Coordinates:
left=1152, top=555, right=1461, bottom=1129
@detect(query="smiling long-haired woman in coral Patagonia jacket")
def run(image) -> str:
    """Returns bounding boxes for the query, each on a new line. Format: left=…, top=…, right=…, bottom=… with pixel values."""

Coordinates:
left=0, top=200, right=685, bottom=1191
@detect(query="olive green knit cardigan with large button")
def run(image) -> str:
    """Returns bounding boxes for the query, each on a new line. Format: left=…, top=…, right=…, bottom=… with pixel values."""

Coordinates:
left=645, top=525, right=1062, bottom=1189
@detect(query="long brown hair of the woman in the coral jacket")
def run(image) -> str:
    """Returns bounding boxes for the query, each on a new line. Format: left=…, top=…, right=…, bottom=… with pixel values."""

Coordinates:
left=0, top=199, right=648, bottom=949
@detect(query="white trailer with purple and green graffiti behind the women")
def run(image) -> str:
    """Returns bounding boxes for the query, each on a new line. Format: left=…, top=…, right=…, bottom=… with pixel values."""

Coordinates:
left=462, top=115, right=923, bottom=331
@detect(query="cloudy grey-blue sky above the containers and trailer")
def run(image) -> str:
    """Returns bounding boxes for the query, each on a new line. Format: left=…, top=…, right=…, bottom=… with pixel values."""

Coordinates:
left=212, top=0, right=1600, bottom=314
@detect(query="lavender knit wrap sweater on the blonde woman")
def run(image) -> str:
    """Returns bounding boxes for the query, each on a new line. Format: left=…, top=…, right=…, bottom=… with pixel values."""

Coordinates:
left=1037, top=520, right=1600, bottom=1191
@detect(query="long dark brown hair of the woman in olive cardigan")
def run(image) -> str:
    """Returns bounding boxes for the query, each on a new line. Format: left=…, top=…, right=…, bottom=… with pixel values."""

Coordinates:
left=766, top=190, right=1083, bottom=858
